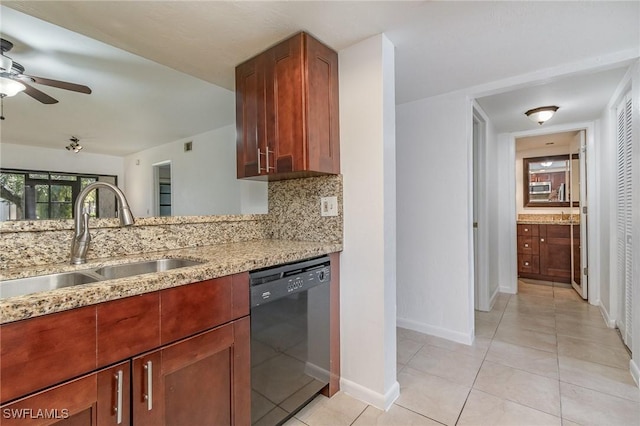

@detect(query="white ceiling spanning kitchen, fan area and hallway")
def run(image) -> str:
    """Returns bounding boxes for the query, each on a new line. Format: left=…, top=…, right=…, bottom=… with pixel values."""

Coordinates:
left=0, top=1, right=640, bottom=155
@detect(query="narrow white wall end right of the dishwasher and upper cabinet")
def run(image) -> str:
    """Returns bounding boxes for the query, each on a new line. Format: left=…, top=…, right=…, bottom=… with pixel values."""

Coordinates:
left=339, top=35, right=399, bottom=409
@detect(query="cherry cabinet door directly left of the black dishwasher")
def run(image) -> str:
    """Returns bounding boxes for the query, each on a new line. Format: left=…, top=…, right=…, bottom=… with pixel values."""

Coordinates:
left=132, top=317, right=251, bottom=426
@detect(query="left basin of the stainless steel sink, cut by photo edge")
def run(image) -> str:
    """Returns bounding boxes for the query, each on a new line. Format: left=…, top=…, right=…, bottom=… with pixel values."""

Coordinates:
left=0, top=271, right=104, bottom=299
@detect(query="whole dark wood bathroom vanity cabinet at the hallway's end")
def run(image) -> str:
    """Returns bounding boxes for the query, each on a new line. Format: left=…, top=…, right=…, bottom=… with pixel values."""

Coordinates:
left=517, top=224, right=571, bottom=283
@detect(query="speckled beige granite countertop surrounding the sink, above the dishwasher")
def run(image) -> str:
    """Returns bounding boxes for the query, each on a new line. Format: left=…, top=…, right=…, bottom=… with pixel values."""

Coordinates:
left=0, top=240, right=342, bottom=324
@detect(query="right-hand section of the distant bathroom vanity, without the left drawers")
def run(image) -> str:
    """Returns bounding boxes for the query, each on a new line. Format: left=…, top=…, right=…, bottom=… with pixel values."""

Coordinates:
left=540, top=225, right=571, bottom=282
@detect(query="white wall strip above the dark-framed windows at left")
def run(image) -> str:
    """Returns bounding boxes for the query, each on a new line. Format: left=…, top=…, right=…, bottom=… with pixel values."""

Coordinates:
left=0, top=141, right=124, bottom=186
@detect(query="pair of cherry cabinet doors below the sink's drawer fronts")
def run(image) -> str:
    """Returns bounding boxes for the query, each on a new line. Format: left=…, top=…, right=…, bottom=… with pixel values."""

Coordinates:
left=0, top=317, right=250, bottom=426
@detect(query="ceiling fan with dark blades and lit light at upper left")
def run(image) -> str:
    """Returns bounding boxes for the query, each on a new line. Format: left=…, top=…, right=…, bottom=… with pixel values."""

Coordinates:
left=0, top=38, right=91, bottom=104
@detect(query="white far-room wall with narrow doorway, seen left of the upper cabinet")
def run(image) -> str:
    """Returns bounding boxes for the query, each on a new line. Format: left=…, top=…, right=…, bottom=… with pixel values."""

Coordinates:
left=124, top=125, right=268, bottom=217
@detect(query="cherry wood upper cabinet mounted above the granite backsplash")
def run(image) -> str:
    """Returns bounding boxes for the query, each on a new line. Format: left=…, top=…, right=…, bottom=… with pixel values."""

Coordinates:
left=236, top=32, right=340, bottom=180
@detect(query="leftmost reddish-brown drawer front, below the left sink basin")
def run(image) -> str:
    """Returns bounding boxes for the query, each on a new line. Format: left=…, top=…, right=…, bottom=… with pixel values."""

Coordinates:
left=0, top=306, right=96, bottom=402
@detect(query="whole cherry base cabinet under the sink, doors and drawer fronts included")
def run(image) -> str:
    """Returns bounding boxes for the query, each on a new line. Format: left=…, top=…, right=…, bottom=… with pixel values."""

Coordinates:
left=0, top=273, right=251, bottom=426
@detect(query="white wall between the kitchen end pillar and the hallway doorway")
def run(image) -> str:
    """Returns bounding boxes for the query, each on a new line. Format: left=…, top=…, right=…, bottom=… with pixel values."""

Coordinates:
left=396, top=94, right=474, bottom=343
